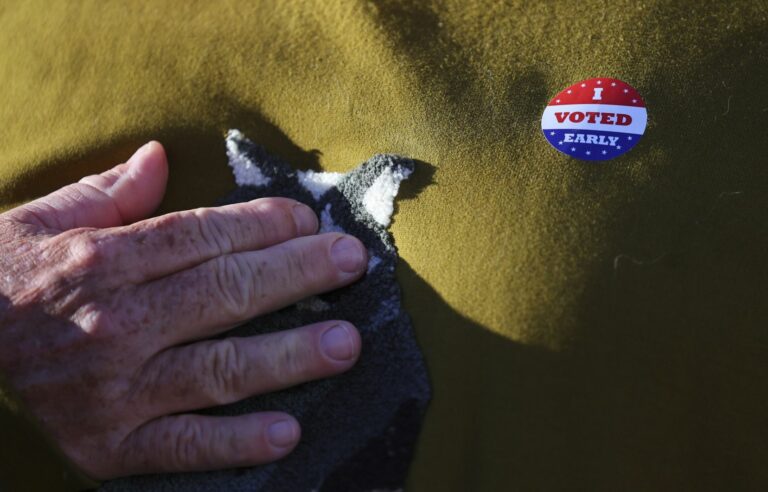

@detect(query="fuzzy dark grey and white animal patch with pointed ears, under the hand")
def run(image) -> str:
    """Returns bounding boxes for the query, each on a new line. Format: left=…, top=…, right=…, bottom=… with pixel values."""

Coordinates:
left=100, top=131, right=429, bottom=492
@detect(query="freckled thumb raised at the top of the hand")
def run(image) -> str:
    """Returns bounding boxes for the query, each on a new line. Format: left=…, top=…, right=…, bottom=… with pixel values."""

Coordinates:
left=11, top=141, right=168, bottom=231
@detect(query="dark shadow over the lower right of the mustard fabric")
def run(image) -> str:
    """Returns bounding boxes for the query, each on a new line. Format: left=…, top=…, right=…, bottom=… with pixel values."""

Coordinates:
left=398, top=17, right=768, bottom=490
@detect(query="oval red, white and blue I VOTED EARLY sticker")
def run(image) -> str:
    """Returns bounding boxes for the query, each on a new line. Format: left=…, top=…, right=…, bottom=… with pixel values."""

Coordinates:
left=541, top=77, right=648, bottom=161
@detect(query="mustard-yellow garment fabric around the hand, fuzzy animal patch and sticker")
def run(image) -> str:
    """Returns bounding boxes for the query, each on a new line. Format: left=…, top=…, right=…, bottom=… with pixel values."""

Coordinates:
left=0, top=0, right=768, bottom=491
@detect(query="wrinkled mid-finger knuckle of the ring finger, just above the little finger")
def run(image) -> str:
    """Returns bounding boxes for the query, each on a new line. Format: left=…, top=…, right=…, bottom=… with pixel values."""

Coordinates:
left=203, top=340, right=246, bottom=405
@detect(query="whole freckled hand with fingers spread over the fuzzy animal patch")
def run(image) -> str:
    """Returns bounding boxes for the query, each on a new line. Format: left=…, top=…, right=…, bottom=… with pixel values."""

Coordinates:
left=0, top=142, right=367, bottom=479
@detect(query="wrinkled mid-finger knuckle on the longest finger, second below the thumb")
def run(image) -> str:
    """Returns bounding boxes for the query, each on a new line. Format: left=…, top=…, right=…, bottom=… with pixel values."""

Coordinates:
left=213, top=255, right=263, bottom=318
